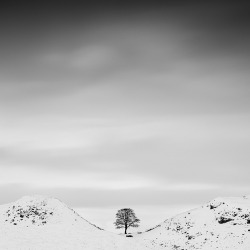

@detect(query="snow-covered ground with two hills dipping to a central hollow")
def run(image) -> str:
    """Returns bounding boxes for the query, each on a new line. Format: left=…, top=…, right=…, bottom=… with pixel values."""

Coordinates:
left=0, top=195, right=250, bottom=250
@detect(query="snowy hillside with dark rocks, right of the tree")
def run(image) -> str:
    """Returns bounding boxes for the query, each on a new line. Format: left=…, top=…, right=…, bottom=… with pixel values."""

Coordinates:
left=139, top=197, right=250, bottom=250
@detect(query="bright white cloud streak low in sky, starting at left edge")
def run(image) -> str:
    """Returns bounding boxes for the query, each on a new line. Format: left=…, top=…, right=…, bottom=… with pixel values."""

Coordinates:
left=0, top=165, right=153, bottom=190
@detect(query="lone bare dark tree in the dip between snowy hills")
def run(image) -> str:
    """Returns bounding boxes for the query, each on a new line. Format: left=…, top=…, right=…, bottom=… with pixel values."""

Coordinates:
left=114, top=208, right=140, bottom=234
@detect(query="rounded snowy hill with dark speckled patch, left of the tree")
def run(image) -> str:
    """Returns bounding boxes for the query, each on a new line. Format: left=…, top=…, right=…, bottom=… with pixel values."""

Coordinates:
left=0, top=196, right=133, bottom=250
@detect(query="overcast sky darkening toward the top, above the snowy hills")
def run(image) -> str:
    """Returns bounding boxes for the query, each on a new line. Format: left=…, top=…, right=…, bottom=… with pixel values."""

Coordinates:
left=0, top=1, right=250, bottom=232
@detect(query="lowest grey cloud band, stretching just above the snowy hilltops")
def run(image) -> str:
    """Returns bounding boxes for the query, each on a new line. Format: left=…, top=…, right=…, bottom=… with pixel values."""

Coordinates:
left=0, top=183, right=249, bottom=208
